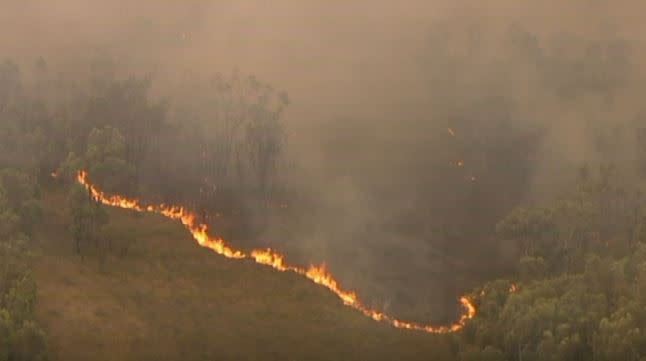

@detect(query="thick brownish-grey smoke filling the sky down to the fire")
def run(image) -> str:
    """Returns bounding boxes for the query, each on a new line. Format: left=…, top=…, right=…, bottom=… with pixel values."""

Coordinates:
left=0, top=0, right=646, bottom=319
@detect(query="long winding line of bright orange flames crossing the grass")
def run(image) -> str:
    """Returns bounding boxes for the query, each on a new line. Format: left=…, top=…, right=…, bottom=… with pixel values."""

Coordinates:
left=77, top=171, right=476, bottom=333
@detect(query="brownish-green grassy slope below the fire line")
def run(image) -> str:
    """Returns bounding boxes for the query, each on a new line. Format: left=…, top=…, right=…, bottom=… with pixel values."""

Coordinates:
left=30, top=193, right=456, bottom=361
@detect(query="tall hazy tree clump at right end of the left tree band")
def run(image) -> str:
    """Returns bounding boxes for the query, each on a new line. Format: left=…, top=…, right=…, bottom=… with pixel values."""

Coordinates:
left=187, top=73, right=289, bottom=202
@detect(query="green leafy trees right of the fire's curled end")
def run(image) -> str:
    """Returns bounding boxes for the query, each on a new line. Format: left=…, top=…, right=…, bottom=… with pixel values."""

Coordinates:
left=460, top=167, right=646, bottom=361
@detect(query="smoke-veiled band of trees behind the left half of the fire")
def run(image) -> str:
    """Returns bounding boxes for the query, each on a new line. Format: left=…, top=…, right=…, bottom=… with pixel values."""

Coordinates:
left=0, top=59, right=289, bottom=240
